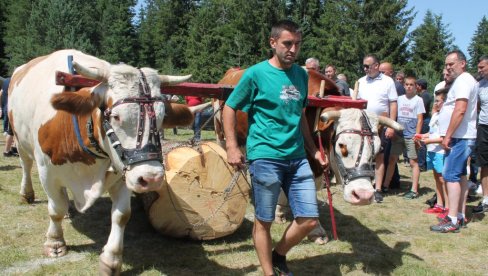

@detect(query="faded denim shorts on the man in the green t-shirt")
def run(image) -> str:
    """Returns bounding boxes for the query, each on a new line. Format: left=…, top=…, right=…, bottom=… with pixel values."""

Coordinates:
left=249, top=158, right=319, bottom=222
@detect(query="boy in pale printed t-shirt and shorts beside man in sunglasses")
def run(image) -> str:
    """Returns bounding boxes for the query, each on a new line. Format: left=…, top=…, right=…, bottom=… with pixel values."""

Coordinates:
left=385, top=77, right=425, bottom=199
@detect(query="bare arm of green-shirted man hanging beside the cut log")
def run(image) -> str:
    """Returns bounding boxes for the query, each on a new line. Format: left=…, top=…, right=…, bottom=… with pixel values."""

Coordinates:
left=222, top=105, right=245, bottom=169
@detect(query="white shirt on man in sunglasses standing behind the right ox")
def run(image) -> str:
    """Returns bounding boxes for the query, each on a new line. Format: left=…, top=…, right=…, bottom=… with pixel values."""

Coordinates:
left=357, top=73, right=398, bottom=115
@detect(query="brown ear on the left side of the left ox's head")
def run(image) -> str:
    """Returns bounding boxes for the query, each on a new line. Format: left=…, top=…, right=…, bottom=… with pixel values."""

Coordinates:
left=51, top=88, right=102, bottom=115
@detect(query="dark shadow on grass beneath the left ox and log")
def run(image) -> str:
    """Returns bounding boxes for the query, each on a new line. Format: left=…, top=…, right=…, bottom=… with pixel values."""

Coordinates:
left=68, top=197, right=257, bottom=275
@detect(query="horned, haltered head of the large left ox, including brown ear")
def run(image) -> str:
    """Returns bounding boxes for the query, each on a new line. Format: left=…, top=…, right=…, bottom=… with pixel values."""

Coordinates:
left=51, top=61, right=191, bottom=192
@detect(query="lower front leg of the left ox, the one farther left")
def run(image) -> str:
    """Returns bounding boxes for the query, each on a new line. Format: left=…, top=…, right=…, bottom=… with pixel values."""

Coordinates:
left=43, top=182, right=68, bottom=257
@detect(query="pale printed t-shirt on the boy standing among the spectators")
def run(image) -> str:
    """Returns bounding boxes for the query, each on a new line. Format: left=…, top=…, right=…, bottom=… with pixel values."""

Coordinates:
left=397, top=95, right=425, bottom=138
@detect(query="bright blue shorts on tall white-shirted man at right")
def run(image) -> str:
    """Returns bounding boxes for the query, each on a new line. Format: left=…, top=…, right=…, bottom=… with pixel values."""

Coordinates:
left=442, top=138, right=476, bottom=182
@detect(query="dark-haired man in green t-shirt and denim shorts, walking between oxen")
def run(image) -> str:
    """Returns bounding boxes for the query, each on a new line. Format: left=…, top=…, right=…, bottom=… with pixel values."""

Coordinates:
left=223, top=20, right=328, bottom=275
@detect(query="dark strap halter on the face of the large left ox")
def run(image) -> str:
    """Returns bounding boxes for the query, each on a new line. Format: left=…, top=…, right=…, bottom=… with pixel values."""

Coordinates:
left=102, top=69, right=164, bottom=171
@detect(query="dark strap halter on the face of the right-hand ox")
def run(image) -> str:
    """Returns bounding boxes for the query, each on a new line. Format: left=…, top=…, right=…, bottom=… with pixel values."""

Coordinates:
left=334, top=110, right=378, bottom=185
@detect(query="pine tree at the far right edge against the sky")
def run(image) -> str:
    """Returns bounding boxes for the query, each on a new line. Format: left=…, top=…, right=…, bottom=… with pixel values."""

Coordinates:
left=468, top=16, right=488, bottom=73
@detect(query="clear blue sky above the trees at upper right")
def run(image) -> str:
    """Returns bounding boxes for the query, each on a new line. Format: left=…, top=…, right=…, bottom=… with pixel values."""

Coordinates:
left=407, top=0, right=488, bottom=56
